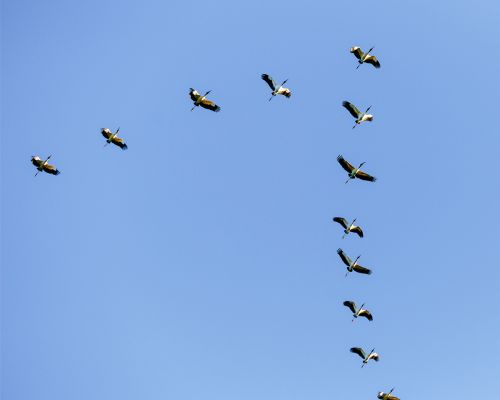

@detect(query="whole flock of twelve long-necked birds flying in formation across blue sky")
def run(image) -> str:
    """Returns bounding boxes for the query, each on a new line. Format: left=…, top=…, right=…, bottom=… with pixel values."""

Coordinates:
left=31, top=47, right=399, bottom=400
